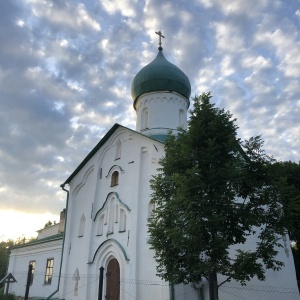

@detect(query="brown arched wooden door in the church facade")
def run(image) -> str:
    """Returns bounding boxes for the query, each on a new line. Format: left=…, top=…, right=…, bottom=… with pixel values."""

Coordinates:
left=105, top=258, right=120, bottom=300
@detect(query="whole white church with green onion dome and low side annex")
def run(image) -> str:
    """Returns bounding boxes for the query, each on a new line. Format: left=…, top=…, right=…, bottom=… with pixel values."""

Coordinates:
left=4, top=37, right=300, bottom=300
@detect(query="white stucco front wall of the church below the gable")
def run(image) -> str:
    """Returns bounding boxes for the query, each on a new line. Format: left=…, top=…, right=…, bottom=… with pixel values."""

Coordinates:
left=58, top=127, right=168, bottom=299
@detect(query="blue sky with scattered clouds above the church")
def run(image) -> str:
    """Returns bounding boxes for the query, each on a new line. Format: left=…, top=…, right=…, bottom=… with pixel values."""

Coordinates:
left=0, top=0, right=300, bottom=240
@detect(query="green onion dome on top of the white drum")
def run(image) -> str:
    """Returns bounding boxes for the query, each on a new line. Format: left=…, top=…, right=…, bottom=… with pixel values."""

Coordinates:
left=131, top=49, right=191, bottom=108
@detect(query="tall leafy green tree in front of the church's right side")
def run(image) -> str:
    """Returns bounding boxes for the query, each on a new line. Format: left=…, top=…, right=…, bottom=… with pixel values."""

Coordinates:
left=149, top=93, right=284, bottom=300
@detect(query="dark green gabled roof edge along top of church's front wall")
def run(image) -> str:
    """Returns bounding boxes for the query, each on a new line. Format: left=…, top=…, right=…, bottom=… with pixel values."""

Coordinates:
left=61, top=123, right=162, bottom=186
